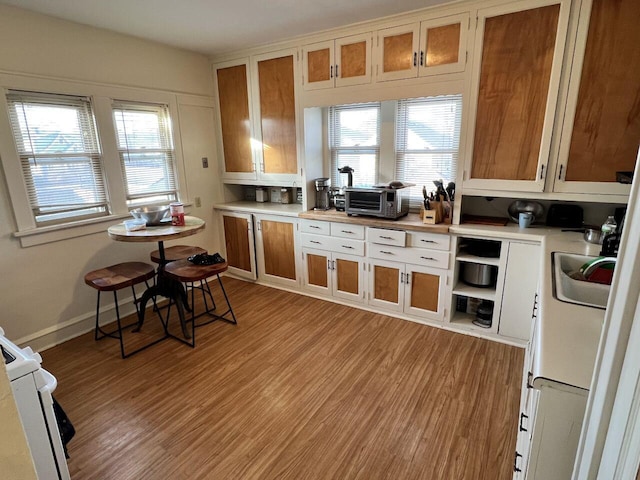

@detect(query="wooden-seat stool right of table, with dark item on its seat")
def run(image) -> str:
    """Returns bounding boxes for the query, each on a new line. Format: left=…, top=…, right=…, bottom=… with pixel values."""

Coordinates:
left=164, top=260, right=238, bottom=347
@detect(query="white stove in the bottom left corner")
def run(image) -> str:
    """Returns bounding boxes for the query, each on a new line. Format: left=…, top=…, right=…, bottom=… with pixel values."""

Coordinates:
left=0, top=328, right=70, bottom=480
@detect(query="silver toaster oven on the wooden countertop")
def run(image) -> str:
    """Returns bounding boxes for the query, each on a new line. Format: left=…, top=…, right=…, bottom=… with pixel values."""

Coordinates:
left=344, top=187, right=409, bottom=219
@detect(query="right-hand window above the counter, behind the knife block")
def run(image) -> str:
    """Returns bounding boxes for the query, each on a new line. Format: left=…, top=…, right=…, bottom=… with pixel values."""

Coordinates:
left=396, top=95, right=462, bottom=208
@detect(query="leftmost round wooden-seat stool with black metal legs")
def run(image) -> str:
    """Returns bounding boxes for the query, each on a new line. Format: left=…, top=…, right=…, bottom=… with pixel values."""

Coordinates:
left=84, top=262, right=160, bottom=358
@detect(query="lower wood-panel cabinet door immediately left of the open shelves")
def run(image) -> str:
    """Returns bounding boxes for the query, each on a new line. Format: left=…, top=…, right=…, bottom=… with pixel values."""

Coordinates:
left=404, top=265, right=447, bottom=320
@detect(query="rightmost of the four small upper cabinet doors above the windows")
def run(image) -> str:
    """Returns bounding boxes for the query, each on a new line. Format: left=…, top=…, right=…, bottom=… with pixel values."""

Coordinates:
left=419, top=13, right=469, bottom=77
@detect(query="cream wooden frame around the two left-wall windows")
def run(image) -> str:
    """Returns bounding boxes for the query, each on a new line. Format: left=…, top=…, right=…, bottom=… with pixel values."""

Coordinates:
left=0, top=77, right=185, bottom=247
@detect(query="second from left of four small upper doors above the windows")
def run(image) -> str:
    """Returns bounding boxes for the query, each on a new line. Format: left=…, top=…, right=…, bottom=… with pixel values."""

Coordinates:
left=334, top=33, right=371, bottom=87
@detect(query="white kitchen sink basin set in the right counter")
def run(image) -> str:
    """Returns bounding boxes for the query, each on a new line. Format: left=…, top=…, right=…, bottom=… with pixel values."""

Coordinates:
left=552, top=252, right=611, bottom=309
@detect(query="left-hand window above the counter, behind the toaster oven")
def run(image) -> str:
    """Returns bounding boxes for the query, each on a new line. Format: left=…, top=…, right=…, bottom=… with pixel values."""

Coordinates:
left=329, top=103, right=380, bottom=187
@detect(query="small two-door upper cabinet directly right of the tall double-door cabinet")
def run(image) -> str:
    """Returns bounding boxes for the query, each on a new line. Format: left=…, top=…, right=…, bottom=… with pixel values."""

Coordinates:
left=302, top=33, right=371, bottom=90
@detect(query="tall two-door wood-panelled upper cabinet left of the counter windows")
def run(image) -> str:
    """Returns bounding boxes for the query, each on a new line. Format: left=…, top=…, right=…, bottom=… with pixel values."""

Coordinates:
left=215, top=49, right=300, bottom=186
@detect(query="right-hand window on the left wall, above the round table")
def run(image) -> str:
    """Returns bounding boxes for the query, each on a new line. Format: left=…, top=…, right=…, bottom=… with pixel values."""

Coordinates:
left=113, top=102, right=178, bottom=206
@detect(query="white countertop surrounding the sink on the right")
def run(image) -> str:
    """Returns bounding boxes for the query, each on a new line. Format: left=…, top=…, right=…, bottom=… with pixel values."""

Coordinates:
left=531, top=232, right=605, bottom=390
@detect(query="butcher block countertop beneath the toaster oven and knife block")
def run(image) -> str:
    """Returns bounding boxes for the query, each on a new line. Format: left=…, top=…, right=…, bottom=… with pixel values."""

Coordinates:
left=298, top=209, right=450, bottom=233
